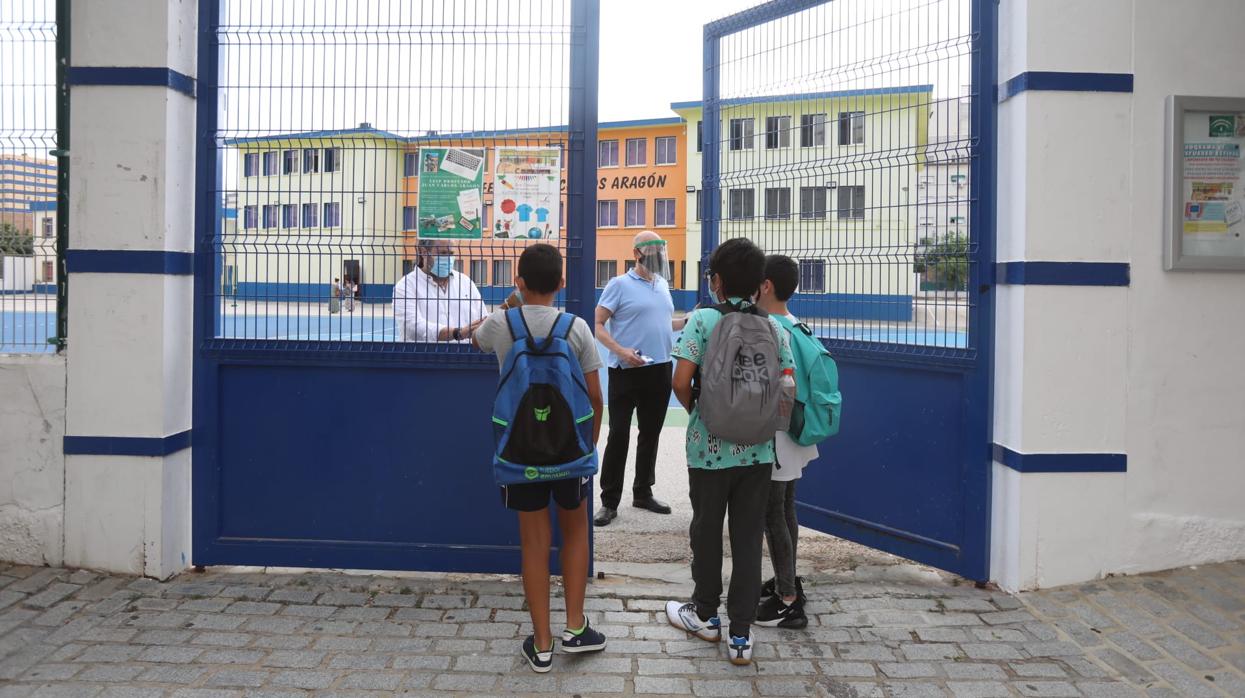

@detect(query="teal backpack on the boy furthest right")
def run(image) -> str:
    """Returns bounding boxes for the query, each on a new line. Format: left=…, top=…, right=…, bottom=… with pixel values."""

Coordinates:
left=772, top=315, right=843, bottom=445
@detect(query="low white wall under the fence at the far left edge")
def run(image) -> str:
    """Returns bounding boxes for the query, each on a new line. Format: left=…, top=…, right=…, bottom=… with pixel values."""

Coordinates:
left=0, top=355, right=65, bottom=565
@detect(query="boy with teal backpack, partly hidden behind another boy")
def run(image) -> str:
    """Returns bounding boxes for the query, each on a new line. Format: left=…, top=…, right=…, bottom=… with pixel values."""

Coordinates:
left=756, top=255, right=842, bottom=628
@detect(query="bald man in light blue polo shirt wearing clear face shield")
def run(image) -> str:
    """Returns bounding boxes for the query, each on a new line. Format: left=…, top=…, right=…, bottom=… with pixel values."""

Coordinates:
left=594, top=230, right=684, bottom=526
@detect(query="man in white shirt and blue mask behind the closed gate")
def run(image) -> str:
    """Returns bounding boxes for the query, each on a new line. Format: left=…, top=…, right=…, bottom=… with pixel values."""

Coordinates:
left=393, top=239, right=488, bottom=342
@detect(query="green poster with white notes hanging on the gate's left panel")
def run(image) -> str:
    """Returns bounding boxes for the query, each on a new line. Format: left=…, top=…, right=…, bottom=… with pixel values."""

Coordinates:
left=418, top=148, right=484, bottom=239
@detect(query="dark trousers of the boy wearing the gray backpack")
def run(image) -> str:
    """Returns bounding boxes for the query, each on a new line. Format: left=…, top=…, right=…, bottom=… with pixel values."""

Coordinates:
left=687, top=463, right=772, bottom=637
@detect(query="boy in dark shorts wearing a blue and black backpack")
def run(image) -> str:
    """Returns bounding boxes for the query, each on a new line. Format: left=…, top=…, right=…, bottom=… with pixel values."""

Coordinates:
left=472, top=243, right=605, bottom=673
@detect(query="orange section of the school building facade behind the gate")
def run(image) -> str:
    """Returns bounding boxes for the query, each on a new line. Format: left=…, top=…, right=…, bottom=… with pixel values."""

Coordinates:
left=402, top=117, right=687, bottom=295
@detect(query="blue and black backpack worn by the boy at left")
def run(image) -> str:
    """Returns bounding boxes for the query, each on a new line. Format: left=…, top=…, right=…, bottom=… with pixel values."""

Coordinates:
left=493, top=307, right=596, bottom=485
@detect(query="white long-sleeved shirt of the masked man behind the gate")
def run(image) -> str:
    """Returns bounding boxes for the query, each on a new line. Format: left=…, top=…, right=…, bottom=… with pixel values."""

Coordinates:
left=393, top=269, right=488, bottom=342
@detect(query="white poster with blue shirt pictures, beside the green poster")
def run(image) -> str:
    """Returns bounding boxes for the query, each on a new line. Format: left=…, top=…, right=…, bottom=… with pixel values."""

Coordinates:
left=493, top=146, right=561, bottom=240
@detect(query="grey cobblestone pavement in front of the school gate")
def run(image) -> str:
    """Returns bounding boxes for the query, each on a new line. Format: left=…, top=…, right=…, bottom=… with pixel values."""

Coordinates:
left=0, top=564, right=1245, bottom=698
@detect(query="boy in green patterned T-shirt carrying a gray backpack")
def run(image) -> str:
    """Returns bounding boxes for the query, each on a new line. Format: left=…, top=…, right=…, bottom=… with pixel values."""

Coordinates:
left=666, top=239, right=794, bottom=664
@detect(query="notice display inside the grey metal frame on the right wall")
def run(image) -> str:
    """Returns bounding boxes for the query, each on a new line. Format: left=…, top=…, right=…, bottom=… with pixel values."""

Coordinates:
left=1182, top=109, right=1245, bottom=256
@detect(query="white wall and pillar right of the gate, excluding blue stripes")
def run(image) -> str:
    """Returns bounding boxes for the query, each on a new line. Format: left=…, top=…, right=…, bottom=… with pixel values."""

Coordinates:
left=992, top=0, right=1245, bottom=589
